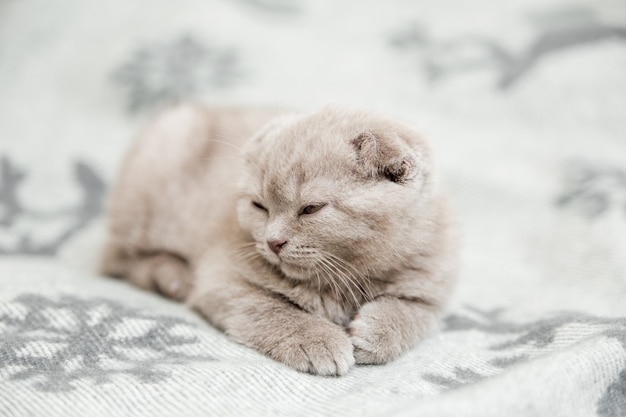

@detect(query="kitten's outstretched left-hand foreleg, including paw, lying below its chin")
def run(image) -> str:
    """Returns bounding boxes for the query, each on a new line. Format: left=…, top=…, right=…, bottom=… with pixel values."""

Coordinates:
left=188, top=260, right=354, bottom=375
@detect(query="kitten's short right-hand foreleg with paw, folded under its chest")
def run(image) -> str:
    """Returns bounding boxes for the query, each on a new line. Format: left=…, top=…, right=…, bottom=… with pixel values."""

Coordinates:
left=349, top=296, right=439, bottom=364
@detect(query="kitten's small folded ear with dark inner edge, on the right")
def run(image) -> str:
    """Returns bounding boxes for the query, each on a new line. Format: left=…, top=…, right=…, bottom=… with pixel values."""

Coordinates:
left=351, top=131, right=422, bottom=184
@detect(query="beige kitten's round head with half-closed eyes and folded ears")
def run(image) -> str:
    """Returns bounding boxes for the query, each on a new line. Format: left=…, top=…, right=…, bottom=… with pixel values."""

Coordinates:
left=237, top=109, right=436, bottom=280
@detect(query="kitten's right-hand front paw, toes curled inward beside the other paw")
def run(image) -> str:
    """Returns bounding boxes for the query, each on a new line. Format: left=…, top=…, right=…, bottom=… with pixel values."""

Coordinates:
left=348, top=306, right=404, bottom=365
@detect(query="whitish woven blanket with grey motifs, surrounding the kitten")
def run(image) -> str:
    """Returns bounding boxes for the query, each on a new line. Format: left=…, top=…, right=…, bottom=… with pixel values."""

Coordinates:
left=0, top=0, right=626, bottom=417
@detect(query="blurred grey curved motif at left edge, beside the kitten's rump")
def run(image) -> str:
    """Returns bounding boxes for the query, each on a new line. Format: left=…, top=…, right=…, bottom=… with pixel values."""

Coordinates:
left=0, top=156, right=106, bottom=255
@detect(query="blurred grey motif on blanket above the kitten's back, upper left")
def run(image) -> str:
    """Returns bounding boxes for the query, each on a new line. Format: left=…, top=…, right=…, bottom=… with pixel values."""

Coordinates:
left=113, top=35, right=241, bottom=111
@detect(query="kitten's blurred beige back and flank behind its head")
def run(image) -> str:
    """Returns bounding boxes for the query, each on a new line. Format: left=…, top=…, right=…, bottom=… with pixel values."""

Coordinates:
left=110, top=104, right=279, bottom=258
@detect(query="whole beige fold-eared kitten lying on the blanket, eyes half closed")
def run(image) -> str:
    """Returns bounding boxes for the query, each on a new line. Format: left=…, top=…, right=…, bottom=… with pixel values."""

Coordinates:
left=102, top=105, right=456, bottom=375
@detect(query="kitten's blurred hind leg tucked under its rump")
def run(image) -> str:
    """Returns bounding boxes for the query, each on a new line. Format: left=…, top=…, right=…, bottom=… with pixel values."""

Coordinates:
left=101, top=245, right=193, bottom=300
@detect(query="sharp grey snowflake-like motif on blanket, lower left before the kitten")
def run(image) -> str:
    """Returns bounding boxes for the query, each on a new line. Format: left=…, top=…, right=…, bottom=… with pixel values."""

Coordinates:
left=0, top=294, right=212, bottom=391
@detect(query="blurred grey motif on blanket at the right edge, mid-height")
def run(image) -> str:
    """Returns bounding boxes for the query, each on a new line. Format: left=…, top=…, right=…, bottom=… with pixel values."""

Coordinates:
left=556, top=161, right=626, bottom=219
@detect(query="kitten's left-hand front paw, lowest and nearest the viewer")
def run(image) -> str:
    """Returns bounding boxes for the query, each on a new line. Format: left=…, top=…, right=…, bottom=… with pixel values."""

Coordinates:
left=269, top=321, right=354, bottom=376
